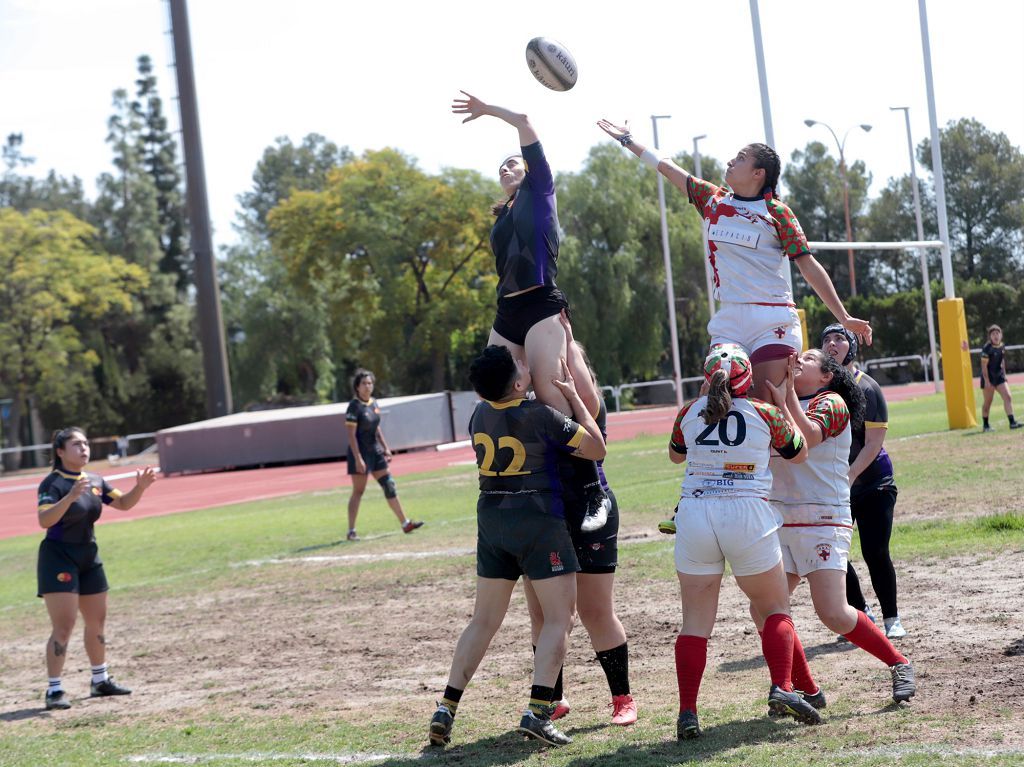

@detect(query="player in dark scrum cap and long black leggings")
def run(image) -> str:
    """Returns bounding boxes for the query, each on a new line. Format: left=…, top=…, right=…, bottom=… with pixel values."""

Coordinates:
left=821, top=324, right=906, bottom=639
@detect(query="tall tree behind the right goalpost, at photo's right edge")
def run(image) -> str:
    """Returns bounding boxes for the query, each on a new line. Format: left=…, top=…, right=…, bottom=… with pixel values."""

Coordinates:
left=918, top=118, right=1024, bottom=280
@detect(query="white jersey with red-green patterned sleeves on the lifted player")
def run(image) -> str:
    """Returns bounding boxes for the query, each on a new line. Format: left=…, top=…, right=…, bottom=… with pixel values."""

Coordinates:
left=686, top=176, right=811, bottom=304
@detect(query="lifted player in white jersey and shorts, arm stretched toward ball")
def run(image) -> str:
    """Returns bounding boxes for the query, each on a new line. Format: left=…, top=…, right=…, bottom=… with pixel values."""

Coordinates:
left=597, top=120, right=871, bottom=399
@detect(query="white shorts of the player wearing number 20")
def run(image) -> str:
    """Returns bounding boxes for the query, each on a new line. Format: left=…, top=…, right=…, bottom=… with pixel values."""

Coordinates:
left=676, top=498, right=782, bottom=576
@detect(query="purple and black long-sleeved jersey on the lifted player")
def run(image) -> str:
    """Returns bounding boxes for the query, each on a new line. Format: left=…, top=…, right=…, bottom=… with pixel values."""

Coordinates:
left=490, top=141, right=558, bottom=298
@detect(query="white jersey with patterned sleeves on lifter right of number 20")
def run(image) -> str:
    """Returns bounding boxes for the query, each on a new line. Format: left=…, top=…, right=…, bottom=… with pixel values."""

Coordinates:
left=769, top=391, right=853, bottom=526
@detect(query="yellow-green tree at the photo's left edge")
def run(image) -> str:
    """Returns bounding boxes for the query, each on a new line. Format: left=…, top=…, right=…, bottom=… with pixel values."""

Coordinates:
left=0, top=208, right=147, bottom=460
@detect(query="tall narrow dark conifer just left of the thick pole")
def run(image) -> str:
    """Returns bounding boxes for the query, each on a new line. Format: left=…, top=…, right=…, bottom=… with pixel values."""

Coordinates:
left=131, top=55, right=191, bottom=293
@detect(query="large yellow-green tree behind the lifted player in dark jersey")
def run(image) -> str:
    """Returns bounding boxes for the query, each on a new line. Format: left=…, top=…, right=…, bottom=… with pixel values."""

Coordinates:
left=268, top=150, right=499, bottom=392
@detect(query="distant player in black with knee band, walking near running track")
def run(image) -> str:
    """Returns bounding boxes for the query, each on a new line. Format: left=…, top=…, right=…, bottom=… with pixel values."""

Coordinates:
left=345, top=370, right=423, bottom=541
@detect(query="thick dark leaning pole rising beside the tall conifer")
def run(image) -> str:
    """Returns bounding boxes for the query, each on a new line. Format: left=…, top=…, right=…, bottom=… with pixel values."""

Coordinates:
left=169, top=0, right=231, bottom=418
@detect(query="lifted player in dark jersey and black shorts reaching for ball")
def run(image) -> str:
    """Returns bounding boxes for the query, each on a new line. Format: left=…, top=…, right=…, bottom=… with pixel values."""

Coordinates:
left=452, top=91, right=611, bottom=531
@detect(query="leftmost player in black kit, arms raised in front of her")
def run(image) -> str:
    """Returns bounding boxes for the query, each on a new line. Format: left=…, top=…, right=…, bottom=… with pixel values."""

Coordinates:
left=37, top=427, right=156, bottom=709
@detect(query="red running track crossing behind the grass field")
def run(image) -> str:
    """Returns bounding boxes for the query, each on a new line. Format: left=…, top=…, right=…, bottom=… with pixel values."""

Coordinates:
left=0, top=375, right=1024, bottom=540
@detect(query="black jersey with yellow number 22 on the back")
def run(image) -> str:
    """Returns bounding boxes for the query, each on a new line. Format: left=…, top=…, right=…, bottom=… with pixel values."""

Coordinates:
left=469, top=399, right=586, bottom=517
